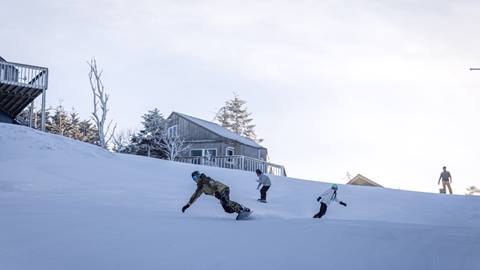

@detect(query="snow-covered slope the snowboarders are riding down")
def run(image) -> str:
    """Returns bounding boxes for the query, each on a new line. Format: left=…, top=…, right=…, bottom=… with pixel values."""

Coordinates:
left=0, top=124, right=480, bottom=270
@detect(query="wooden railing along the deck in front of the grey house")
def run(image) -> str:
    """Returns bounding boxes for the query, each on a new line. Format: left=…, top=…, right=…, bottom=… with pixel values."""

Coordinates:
left=175, top=156, right=287, bottom=176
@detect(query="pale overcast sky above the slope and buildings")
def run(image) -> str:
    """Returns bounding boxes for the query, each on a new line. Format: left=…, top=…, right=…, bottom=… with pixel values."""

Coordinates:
left=0, top=0, right=480, bottom=194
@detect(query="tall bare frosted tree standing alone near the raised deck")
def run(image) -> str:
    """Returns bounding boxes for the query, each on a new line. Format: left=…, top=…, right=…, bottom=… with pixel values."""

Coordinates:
left=87, top=58, right=117, bottom=149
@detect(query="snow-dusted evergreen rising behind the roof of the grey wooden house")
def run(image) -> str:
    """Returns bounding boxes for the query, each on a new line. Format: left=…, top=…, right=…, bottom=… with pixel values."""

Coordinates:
left=215, top=93, right=263, bottom=142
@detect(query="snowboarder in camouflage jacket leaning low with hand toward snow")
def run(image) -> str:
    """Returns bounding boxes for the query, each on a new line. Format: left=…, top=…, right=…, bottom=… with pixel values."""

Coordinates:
left=182, top=171, right=251, bottom=220
